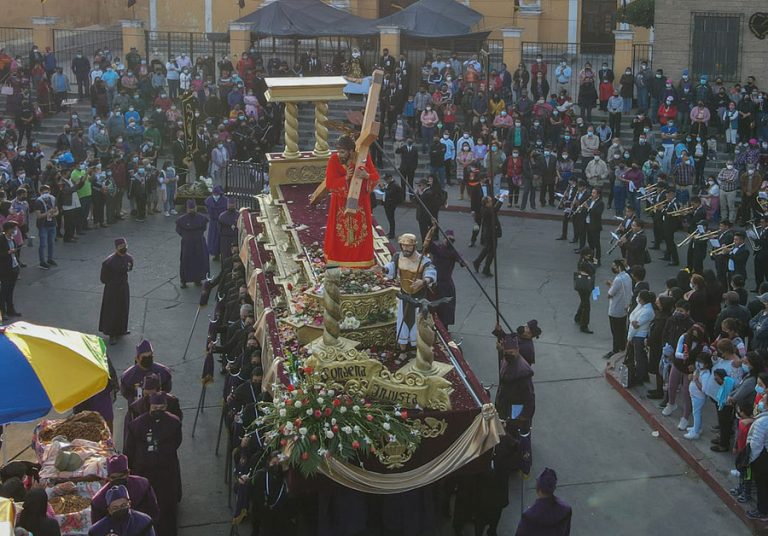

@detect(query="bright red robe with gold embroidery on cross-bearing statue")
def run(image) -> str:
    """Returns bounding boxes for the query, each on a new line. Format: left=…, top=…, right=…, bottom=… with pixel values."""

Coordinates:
left=323, top=153, right=379, bottom=268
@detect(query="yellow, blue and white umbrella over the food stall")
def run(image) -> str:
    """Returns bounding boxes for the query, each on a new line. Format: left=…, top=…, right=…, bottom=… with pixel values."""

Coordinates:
left=0, top=322, right=109, bottom=424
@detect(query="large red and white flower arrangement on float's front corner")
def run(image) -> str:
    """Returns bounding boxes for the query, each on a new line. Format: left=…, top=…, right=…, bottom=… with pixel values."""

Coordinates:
left=254, top=362, right=421, bottom=477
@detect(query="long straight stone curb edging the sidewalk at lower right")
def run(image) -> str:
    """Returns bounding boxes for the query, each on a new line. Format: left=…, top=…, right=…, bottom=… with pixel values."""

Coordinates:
left=604, top=360, right=768, bottom=535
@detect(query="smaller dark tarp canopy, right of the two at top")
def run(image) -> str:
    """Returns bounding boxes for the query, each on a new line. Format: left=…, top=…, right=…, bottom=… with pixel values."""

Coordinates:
left=376, top=0, right=483, bottom=38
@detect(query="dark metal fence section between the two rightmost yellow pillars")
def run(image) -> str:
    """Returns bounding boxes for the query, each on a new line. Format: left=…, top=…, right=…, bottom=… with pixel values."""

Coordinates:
left=510, top=42, right=612, bottom=101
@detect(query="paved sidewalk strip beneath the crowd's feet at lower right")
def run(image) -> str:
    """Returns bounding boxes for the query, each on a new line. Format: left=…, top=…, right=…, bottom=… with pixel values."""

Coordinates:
left=605, top=353, right=768, bottom=534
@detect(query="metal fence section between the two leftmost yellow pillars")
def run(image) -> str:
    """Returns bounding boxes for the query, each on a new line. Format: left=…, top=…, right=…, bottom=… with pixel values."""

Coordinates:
left=53, top=28, right=123, bottom=87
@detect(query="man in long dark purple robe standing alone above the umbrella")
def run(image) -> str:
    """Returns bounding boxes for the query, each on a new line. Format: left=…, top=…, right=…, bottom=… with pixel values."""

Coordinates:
left=99, top=238, right=133, bottom=344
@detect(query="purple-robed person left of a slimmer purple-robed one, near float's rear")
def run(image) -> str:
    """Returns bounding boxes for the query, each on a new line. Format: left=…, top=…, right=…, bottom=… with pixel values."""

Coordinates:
left=176, top=199, right=208, bottom=288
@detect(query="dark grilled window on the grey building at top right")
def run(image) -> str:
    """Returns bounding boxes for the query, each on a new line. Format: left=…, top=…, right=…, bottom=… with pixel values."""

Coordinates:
left=691, top=13, right=743, bottom=80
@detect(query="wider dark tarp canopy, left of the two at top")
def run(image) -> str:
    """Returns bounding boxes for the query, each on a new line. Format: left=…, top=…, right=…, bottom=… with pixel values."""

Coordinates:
left=236, top=0, right=379, bottom=37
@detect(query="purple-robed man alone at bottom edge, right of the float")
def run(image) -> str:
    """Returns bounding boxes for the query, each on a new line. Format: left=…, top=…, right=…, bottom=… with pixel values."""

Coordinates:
left=515, top=467, right=573, bottom=536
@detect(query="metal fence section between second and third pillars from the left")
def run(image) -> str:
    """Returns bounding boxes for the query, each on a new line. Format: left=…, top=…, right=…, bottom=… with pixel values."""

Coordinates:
left=146, top=31, right=229, bottom=80
